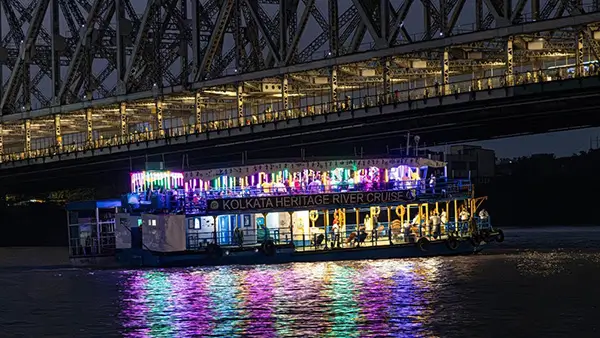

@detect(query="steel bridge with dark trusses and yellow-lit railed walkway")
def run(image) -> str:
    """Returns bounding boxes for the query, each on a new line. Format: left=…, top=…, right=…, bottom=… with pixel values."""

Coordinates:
left=0, top=0, right=600, bottom=172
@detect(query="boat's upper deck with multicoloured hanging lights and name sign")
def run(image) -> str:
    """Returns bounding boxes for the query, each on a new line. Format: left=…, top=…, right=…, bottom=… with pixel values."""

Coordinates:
left=129, top=158, right=471, bottom=214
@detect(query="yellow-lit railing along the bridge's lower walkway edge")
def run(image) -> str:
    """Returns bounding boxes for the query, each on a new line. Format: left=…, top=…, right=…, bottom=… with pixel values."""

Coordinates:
left=0, top=65, right=600, bottom=162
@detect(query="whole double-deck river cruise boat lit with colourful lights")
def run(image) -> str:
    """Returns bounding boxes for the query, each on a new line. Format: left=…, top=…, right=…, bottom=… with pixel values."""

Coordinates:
left=67, top=158, right=504, bottom=266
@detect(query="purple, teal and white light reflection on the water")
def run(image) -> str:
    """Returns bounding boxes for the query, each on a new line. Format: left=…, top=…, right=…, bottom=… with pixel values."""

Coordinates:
left=120, top=258, right=440, bottom=337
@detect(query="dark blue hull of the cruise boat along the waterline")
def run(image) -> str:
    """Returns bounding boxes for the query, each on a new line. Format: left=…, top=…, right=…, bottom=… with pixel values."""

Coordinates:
left=96, top=240, right=483, bottom=267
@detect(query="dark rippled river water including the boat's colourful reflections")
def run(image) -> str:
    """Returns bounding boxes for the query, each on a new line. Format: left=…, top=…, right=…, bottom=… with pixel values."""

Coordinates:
left=0, top=227, right=600, bottom=337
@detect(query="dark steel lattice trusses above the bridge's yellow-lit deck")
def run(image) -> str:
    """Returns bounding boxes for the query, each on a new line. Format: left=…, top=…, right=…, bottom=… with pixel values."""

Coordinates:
left=0, top=0, right=600, bottom=115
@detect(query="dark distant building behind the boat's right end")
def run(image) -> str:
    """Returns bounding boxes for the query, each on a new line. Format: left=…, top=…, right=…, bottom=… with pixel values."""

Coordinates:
left=446, top=145, right=496, bottom=179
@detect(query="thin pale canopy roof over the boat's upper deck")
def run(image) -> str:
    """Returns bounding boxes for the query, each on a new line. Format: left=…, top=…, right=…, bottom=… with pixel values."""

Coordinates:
left=185, top=157, right=446, bottom=180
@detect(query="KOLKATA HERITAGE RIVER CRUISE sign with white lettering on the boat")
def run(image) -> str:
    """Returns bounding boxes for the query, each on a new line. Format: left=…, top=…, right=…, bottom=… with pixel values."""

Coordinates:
left=207, top=190, right=415, bottom=214
